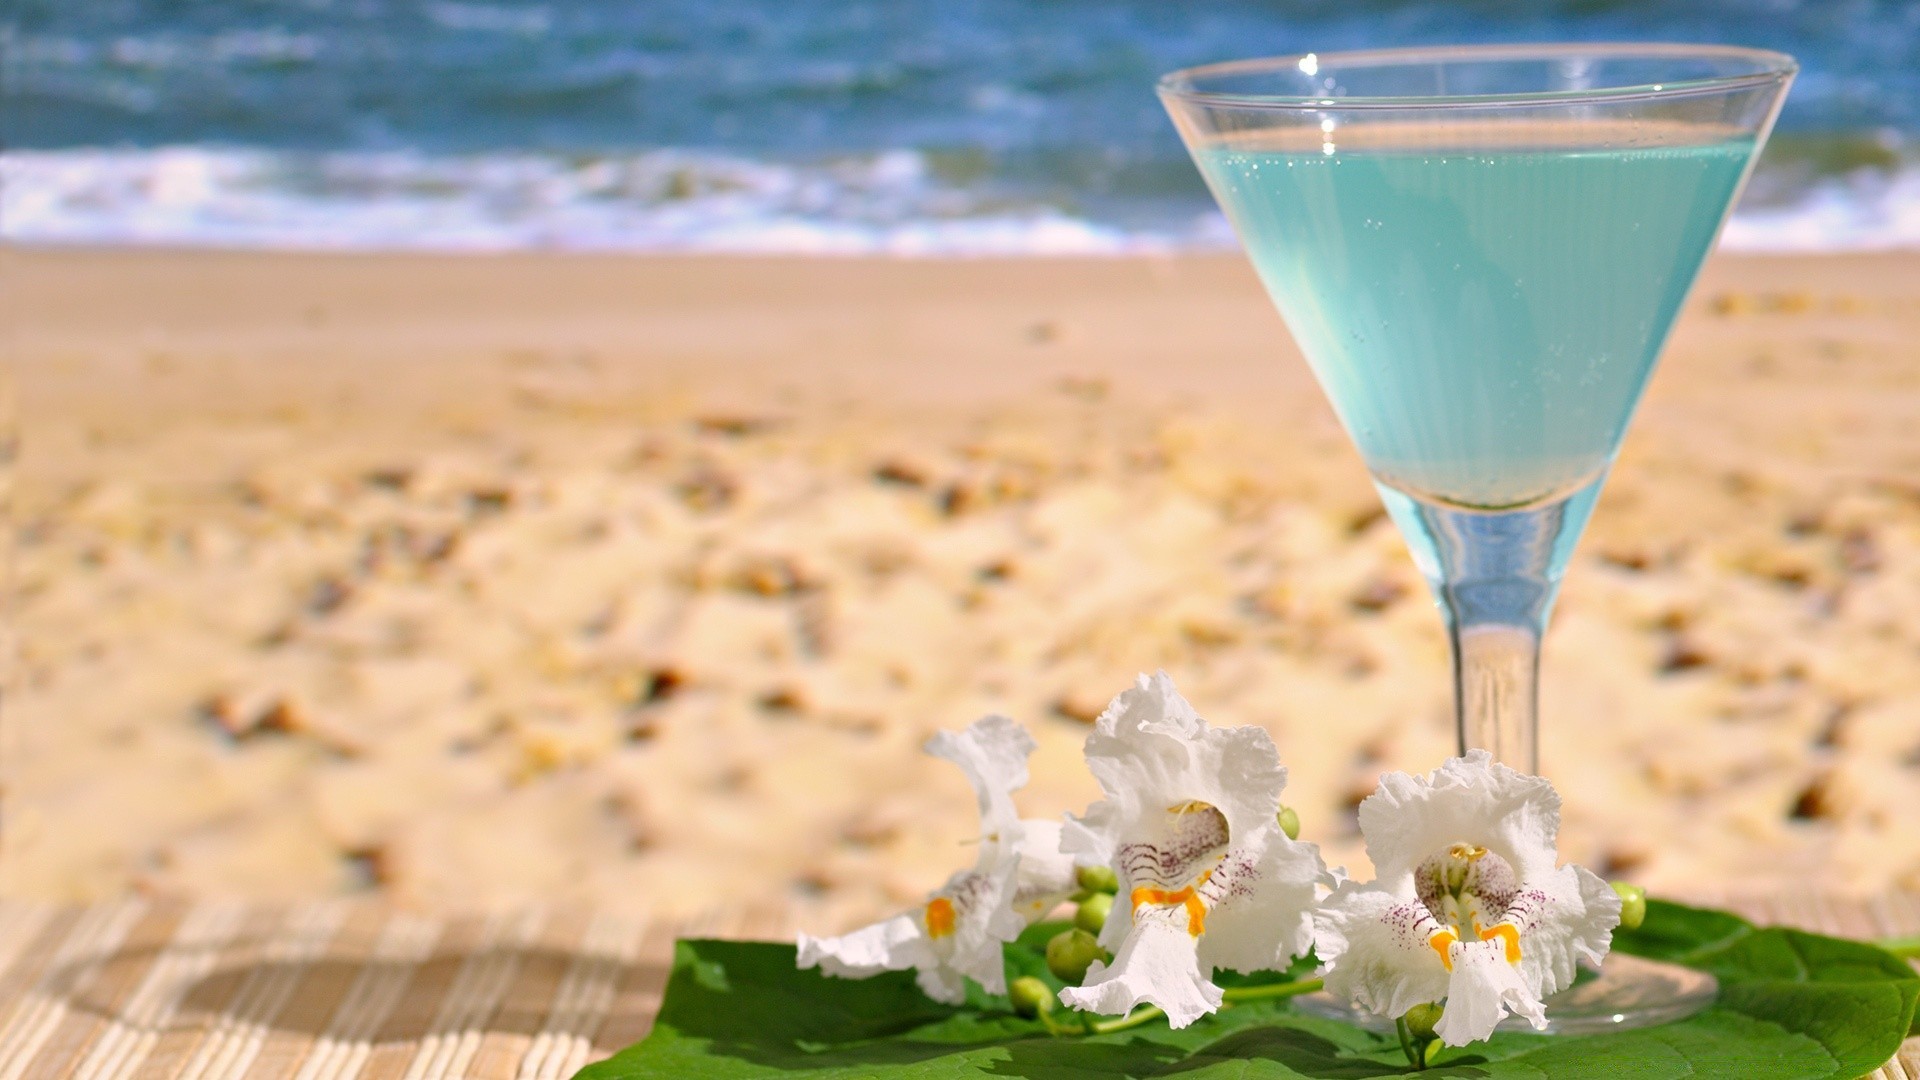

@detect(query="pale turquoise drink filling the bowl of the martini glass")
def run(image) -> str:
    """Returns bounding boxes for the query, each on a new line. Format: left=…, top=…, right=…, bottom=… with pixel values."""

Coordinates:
left=1198, top=135, right=1753, bottom=509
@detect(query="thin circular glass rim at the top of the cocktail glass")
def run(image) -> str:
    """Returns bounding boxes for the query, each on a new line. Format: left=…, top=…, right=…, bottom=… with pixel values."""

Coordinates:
left=1156, top=42, right=1799, bottom=110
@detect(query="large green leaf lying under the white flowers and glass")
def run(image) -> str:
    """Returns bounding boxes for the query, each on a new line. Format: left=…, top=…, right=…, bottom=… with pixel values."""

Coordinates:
left=580, top=901, right=1920, bottom=1080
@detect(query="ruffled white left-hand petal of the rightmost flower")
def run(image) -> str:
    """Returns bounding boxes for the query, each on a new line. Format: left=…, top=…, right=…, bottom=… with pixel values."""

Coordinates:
left=1313, top=882, right=1448, bottom=1017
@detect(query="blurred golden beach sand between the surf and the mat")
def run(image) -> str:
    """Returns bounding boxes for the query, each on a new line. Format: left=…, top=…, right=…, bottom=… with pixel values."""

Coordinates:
left=0, top=252, right=1920, bottom=930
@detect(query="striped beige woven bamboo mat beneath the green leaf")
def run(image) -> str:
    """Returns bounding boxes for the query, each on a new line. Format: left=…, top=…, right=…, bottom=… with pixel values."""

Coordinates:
left=0, top=896, right=1920, bottom=1080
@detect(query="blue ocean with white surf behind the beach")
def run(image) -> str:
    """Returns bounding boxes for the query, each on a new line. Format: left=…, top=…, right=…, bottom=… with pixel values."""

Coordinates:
left=0, top=0, right=1920, bottom=256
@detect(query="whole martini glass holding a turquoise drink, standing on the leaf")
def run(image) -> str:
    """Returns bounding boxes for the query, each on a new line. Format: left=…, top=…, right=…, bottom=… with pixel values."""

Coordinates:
left=1160, top=44, right=1795, bottom=1030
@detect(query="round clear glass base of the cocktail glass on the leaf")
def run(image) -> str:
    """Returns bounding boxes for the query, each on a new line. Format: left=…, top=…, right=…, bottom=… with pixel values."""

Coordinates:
left=1294, top=955, right=1720, bottom=1036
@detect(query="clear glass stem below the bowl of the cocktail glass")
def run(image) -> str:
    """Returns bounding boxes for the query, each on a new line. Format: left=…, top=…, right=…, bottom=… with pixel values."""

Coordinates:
left=1382, top=480, right=1599, bottom=773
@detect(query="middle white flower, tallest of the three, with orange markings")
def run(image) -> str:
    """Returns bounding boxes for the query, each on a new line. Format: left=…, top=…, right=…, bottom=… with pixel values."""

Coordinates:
left=1060, top=673, right=1332, bottom=1028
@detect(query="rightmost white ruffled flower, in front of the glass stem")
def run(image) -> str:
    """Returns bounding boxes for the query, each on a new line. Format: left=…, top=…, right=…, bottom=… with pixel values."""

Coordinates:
left=1315, top=749, right=1620, bottom=1045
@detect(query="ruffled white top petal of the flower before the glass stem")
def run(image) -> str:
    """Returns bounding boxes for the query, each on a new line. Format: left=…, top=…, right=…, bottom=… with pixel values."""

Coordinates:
left=1359, top=749, right=1561, bottom=888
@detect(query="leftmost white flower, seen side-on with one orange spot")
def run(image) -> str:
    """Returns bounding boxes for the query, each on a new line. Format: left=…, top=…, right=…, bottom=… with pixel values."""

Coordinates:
left=799, top=717, right=1073, bottom=1005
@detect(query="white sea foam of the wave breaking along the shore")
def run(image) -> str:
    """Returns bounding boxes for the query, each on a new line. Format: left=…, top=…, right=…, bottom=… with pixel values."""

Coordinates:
left=0, top=146, right=1920, bottom=256
